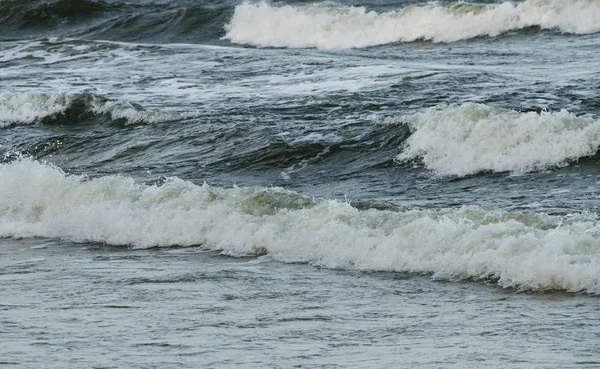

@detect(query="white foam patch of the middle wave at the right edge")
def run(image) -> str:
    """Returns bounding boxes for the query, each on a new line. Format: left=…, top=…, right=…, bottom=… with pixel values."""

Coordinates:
left=394, top=103, right=600, bottom=176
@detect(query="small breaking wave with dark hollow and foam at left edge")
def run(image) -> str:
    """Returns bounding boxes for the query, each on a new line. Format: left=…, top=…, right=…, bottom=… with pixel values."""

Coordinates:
left=0, top=92, right=176, bottom=127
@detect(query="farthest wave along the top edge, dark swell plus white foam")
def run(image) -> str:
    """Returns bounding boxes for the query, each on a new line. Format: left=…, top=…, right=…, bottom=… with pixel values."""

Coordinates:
left=5, top=0, right=600, bottom=45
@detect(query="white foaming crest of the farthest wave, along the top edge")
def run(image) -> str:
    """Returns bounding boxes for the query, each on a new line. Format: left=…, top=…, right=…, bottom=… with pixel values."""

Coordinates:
left=225, top=0, right=600, bottom=49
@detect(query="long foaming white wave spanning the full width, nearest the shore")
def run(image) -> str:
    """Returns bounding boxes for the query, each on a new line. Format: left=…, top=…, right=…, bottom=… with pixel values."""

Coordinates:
left=0, top=159, right=600, bottom=293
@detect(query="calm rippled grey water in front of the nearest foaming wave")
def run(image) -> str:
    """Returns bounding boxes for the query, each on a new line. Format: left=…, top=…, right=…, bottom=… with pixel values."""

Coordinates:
left=0, top=240, right=600, bottom=368
